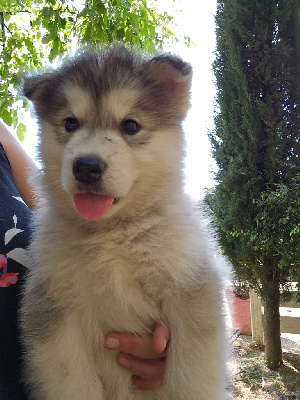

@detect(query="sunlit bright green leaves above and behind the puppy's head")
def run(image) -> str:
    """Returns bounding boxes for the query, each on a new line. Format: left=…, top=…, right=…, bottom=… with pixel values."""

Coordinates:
left=0, top=0, right=177, bottom=140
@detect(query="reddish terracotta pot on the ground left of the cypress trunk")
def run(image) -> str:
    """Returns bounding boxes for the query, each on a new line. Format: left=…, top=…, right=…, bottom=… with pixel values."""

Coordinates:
left=226, top=290, right=252, bottom=336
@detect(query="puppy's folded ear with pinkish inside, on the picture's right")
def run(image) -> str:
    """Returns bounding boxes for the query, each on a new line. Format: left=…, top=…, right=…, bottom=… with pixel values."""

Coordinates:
left=149, top=54, right=192, bottom=118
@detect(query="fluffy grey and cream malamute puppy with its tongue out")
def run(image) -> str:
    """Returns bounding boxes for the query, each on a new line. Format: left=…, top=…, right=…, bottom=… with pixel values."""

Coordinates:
left=22, top=45, right=226, bottom=400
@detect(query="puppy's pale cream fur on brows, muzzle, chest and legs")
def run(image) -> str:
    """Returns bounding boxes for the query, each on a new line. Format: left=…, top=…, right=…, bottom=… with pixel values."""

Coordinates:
left=22, top=48, right=227, bottom=400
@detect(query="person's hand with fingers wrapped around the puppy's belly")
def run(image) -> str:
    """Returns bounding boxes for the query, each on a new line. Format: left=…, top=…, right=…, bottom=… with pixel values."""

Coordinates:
left=104, top=322, right=170, bottom=390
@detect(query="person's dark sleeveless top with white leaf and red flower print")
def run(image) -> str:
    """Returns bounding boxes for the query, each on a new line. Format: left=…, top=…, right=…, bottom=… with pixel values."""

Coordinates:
left=0, top=143, right=32, bottom=400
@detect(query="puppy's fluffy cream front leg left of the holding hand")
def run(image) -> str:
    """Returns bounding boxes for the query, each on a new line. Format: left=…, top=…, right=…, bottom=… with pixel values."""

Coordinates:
left=28, top=314, right=104, bottom=400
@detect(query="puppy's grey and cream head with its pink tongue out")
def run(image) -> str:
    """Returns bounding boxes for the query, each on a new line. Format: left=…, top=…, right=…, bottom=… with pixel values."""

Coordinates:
left=24, top=45, right=191, bottom=219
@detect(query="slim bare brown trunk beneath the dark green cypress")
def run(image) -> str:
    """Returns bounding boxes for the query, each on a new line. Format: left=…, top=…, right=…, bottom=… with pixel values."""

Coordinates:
left=264, top=281, right=282, bottom=370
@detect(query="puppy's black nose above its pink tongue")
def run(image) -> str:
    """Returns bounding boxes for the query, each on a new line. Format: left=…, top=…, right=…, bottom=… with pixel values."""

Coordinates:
left=73, top=157, right=104, bottom=184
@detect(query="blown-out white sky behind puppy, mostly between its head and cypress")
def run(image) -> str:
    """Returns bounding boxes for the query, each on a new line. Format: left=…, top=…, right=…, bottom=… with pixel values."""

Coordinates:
left=23, top=0, right=217, bottom=199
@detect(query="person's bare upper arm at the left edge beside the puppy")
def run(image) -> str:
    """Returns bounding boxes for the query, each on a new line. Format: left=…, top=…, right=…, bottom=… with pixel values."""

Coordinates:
left=0, top=121, right=38, bottom=209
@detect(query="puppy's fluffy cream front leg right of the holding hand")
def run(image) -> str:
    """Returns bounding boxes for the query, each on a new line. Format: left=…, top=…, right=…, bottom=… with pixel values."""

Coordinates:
left=164, top=288, right=227, bottom=400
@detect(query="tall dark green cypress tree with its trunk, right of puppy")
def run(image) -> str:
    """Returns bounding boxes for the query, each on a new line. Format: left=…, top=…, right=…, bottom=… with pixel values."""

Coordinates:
left=207, top=0, right=300, bottom=369
